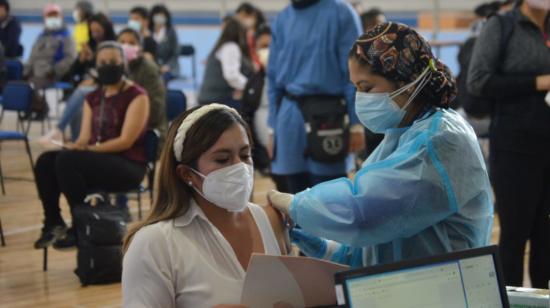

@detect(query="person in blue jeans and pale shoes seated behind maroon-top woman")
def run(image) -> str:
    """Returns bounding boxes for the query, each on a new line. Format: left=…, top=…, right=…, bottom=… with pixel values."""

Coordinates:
left=39, top=13, right=116, bottom=145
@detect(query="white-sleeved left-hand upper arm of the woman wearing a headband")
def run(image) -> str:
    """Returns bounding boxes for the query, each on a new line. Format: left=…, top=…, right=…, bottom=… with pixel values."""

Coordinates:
left=122, top=226, right=176, bottom=308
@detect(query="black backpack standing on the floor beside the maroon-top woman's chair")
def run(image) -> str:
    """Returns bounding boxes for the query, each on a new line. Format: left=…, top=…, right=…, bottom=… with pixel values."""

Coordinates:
left=73, top=196, right=127, bottom=286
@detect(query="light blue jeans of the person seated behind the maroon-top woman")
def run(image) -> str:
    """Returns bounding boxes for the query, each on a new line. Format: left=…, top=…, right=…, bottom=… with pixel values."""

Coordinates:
left=57, top=86, right=96, bottom=141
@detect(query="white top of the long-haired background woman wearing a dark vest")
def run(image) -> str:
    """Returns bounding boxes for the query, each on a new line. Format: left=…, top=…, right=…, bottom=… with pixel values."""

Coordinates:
left=216, top=42, right=248, bottom=90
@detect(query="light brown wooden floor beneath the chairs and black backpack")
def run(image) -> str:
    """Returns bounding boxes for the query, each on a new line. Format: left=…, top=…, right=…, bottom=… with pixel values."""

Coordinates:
left=0, top=115, right=516, bottom=307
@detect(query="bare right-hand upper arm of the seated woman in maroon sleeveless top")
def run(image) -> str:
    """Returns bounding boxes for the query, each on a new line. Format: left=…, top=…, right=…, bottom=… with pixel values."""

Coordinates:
left=120, top=94, right=149, bottom=145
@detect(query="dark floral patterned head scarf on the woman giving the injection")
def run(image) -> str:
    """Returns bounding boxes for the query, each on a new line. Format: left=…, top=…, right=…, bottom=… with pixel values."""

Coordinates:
left=350, top=22, right=456, bottom=108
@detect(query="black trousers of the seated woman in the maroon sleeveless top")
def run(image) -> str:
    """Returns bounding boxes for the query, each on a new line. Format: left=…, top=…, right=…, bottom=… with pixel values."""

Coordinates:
left=34, top=150, right=145, bottom=225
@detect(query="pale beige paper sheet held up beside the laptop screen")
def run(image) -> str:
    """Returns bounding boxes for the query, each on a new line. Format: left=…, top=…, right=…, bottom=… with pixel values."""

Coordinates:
left=241, top=254, right=348, bottom=308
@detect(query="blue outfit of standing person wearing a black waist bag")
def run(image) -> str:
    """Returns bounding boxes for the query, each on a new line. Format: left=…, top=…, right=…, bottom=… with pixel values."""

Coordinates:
left=267, top=0, right=361, bottom=176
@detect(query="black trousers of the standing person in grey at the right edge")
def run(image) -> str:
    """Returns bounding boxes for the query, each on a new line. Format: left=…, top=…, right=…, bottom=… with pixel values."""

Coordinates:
left=490, top=150, right=550, bottom=289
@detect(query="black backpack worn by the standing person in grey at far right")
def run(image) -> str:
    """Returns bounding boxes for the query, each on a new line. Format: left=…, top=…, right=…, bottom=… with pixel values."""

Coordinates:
left=456, top=12, right=515, bottom=119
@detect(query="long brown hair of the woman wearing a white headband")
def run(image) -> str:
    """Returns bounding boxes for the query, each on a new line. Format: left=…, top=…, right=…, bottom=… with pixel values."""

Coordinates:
left=123, top=107, right=252, bottom=252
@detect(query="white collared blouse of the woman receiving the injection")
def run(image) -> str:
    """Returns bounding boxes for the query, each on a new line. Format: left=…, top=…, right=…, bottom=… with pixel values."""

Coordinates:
left=122, top=202, right=281, bottom=308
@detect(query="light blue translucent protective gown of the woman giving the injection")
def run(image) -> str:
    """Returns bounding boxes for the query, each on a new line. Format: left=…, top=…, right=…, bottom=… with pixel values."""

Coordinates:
left=290, top=110, right=493, bottom=266
